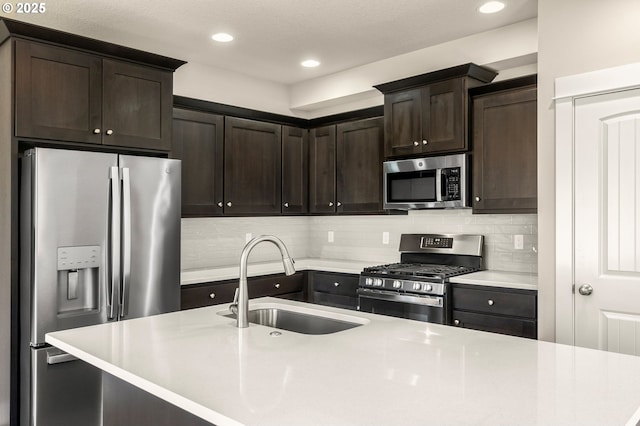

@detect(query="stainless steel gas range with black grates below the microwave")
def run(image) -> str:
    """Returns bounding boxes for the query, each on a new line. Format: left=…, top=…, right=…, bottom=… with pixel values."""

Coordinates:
left=358, top=234, right=484, bottom=324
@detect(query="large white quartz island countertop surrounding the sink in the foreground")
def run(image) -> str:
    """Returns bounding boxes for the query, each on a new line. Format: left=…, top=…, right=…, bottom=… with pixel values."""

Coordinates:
left=46, top=298, right=640, bottom=426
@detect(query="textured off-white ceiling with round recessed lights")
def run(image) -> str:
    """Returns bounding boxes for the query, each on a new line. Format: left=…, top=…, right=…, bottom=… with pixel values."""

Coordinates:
left=0, top=0, right=537, bottom=84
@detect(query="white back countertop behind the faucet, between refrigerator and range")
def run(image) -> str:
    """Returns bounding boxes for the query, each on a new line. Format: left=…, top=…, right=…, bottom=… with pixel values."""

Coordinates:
left=180, top=258, right=384, bottom=285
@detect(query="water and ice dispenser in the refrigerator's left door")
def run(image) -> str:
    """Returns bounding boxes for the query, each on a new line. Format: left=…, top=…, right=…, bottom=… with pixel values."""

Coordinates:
left=57, top=246, right=100, bottom=315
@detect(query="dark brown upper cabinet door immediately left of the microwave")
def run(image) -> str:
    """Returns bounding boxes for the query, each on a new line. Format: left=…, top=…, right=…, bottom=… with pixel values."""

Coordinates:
left=336, top=117, right=384, bottom=213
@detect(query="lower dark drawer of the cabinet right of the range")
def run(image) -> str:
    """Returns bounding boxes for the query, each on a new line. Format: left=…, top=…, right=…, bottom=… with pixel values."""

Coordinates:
left=453, top=310, right=537, bottom=339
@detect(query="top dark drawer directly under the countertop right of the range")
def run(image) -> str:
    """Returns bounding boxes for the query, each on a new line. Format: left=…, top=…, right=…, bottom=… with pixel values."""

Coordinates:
left=452, top=286, right=537, bottom=319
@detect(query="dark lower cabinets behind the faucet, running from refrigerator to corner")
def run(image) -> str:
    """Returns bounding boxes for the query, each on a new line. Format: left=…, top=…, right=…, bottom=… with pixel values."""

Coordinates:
left=180, top=272, right=306, bottom=309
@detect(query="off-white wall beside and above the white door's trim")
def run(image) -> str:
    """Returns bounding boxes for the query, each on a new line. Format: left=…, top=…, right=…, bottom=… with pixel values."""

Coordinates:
left=538, top=0, right=640, bottom=341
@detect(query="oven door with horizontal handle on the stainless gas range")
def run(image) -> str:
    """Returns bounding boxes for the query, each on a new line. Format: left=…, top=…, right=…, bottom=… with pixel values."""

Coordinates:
left=358, top=288, right=447, bottom=324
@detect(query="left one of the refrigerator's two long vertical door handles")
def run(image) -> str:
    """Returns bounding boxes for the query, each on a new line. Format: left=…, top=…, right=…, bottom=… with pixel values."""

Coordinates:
left=107, top=166, right=121, bottom=320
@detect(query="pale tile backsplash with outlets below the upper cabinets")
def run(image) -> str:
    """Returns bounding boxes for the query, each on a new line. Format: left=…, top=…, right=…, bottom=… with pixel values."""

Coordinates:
left=182, top=209, right=538, bottom=273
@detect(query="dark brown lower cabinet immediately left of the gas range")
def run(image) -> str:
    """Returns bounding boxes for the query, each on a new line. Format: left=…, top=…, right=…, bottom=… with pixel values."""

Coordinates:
left=309, top=271, right=360, bottom=310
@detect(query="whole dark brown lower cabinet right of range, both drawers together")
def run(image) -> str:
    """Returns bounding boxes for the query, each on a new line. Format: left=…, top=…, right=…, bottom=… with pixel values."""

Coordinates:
left=451, top=284, right=538, bottom=339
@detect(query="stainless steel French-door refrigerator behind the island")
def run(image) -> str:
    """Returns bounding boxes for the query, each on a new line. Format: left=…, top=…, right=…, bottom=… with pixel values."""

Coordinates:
left=20, top=148, right=181, bottom=426
